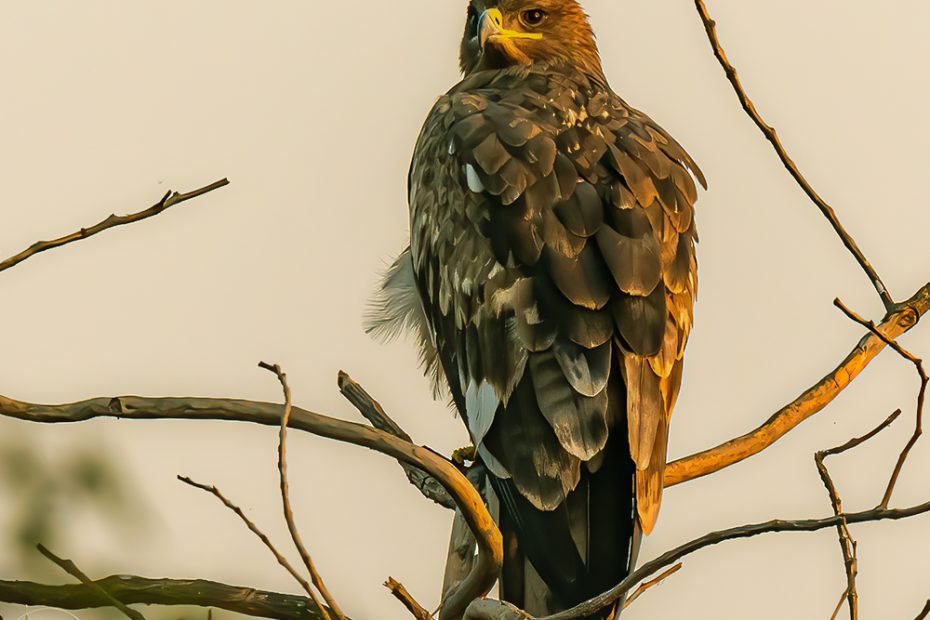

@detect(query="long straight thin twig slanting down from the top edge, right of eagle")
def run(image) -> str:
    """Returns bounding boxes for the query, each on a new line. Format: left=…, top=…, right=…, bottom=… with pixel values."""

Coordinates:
left=694, top=0, right=895, bottom=312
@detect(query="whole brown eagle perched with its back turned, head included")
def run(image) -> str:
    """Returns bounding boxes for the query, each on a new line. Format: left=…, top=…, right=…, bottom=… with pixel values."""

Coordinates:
left=371, top=0, right=706, bottom=618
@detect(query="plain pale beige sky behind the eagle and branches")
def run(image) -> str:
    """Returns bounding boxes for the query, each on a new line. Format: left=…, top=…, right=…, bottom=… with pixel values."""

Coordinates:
left=0, top=0, right=930, bottom=619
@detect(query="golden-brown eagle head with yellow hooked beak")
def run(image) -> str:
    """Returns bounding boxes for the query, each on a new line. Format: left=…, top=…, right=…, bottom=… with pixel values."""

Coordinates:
left=460, top=0, right=604, bottom=80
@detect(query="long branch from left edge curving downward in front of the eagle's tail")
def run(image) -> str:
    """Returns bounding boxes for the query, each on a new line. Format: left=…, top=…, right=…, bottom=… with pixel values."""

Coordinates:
left=0, top=386, right=503, bottom=620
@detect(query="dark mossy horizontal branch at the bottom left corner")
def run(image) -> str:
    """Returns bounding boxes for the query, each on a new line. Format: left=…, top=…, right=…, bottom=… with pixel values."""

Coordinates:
left=0, top=575, right=332, bottom=620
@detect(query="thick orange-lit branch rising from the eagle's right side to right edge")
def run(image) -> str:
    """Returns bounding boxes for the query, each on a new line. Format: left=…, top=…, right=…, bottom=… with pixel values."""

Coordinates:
left=665, top=284, right=930, bottom=487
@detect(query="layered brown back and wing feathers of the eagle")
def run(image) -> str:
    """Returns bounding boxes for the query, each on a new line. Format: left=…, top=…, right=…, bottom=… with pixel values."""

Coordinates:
left=402, top=72, right=703, bottom=532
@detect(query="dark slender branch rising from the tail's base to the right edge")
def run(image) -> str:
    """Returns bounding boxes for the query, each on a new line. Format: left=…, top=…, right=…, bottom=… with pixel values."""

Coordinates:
left=539, top=501, right=930, bottom=620
